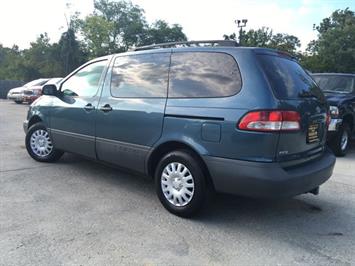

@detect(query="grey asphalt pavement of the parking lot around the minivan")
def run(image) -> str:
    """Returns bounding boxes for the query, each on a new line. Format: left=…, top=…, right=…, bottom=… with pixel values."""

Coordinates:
left=0, top=100, right=355, bottom=266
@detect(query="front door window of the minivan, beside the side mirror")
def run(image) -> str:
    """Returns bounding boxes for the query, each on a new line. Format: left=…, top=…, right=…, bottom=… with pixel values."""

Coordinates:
left=61, top=60, right=107, bottom=97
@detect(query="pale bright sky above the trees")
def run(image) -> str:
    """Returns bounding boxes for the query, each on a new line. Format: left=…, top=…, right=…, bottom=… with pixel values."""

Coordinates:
left=0, top=0, right=355, bottom=50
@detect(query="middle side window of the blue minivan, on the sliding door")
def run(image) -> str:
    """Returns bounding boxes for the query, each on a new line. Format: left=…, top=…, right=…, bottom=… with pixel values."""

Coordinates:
left=111, top=53, right=170, bottom=98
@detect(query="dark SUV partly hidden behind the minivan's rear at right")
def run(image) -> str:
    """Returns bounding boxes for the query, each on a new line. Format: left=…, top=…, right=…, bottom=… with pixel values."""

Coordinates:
left=312, top=73, right=355, bottom=156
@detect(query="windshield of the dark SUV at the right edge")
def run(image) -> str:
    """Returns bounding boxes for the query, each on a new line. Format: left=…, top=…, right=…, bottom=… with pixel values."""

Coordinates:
left=313, top=75, right=355, bottom=93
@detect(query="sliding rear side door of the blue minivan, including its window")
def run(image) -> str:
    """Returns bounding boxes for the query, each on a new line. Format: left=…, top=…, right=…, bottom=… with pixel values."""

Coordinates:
left=96, top=52, right=170, bottom=172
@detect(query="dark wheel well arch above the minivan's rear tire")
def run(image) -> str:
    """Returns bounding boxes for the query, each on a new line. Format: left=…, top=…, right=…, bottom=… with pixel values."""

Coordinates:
left=148, top=141, right=214, bottom=188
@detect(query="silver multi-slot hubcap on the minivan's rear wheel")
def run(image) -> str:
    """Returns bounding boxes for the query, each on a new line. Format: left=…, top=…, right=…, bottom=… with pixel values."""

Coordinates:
left=160, top=162, right=195, bottom=207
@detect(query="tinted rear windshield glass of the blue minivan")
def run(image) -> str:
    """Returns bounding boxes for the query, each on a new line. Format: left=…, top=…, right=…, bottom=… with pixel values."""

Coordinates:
left=258, top=55, right=324, bottom=101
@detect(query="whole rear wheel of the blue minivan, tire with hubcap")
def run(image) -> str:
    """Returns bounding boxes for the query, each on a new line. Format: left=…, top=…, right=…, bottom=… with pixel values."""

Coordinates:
left=155, top=150, right=208, bottom=217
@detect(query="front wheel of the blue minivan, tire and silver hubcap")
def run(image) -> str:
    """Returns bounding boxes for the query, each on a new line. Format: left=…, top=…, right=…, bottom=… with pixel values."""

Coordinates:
left=25, top=123, right=63, bottom=162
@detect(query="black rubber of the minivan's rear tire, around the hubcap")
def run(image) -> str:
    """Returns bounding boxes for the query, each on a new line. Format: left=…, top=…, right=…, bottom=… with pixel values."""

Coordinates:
left=155, top=150, right=206, bottom=217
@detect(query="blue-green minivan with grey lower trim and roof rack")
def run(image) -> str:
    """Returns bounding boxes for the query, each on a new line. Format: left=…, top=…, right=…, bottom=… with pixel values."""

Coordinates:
left=24, top=42, right=335, bottom=216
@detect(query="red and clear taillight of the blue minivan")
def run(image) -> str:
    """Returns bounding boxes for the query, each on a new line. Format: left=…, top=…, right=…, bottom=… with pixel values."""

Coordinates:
left=238, top=111, right=301, bottom=132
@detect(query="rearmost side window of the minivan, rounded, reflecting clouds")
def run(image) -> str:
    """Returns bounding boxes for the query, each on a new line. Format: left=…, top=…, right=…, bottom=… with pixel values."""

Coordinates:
left=169, top=52, right=241, bottom=98
